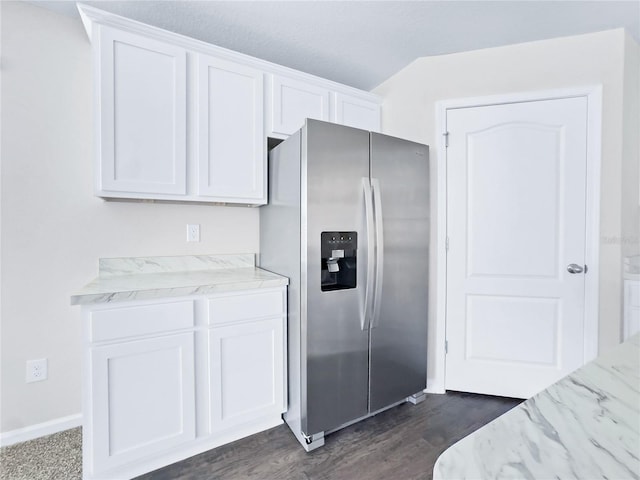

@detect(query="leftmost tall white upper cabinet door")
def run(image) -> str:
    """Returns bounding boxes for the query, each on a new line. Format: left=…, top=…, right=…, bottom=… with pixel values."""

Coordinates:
left=96, top=26, right=187, bottom=198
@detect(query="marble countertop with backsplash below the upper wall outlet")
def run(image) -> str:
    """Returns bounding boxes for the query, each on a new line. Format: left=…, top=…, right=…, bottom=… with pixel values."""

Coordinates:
left=71, top=254, right=289, bottom=305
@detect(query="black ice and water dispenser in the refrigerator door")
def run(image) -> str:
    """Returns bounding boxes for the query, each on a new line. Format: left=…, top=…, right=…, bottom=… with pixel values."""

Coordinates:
left=320, top=232, right=358, bottom=292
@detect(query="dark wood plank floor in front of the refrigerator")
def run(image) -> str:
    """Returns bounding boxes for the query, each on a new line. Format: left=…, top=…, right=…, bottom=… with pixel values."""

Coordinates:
left=138, top=392, right=521, bottom=480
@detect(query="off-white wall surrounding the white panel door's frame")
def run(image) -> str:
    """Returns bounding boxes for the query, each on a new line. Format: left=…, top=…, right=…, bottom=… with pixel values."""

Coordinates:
left=374, top=29, right=638, bottom=390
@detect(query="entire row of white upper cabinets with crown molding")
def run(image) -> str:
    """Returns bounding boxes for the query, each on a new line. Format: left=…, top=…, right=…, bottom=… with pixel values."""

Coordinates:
left=78, top=5, right=380, bottom=205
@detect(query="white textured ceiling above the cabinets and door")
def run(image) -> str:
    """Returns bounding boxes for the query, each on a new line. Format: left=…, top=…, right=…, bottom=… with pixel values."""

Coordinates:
left=23, top=0, right=640, bottom=90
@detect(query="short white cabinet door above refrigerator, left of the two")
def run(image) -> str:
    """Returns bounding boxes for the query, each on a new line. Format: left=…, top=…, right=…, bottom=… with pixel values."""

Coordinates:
left=270, top=75, right=329, bottom=135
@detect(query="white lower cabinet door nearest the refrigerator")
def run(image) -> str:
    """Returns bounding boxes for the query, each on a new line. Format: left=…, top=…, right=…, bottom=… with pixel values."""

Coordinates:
left=209, top=317, right=285, bottom=432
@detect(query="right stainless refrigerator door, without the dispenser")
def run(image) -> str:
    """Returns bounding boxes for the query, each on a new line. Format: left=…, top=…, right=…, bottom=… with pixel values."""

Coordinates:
left=369, top=133, right=429, bottom=412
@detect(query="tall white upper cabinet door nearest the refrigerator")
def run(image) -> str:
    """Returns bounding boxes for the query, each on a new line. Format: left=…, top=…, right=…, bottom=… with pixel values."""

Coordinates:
left=197, top=55, right=266, bottom=203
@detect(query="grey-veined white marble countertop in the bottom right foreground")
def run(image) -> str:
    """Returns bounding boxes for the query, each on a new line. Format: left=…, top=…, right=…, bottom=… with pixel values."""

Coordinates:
left=433, top=334, right=640, bottom=480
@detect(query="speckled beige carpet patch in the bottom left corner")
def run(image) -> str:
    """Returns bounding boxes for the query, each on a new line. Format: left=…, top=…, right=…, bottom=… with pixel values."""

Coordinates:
left=0, top=427, right=82, bottom=480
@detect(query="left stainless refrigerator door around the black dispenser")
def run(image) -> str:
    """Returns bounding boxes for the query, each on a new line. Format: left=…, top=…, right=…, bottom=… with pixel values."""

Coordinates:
left=304, top=120, right=369, bottom=435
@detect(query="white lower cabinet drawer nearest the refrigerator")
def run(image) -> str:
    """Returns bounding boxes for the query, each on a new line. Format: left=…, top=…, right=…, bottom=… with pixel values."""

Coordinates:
left=209, top=291, right=285, bottom=324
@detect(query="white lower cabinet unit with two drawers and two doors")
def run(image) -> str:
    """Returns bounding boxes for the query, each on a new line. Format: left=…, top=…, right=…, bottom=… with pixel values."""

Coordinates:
left=83, top=287, right=286, bottom=479
